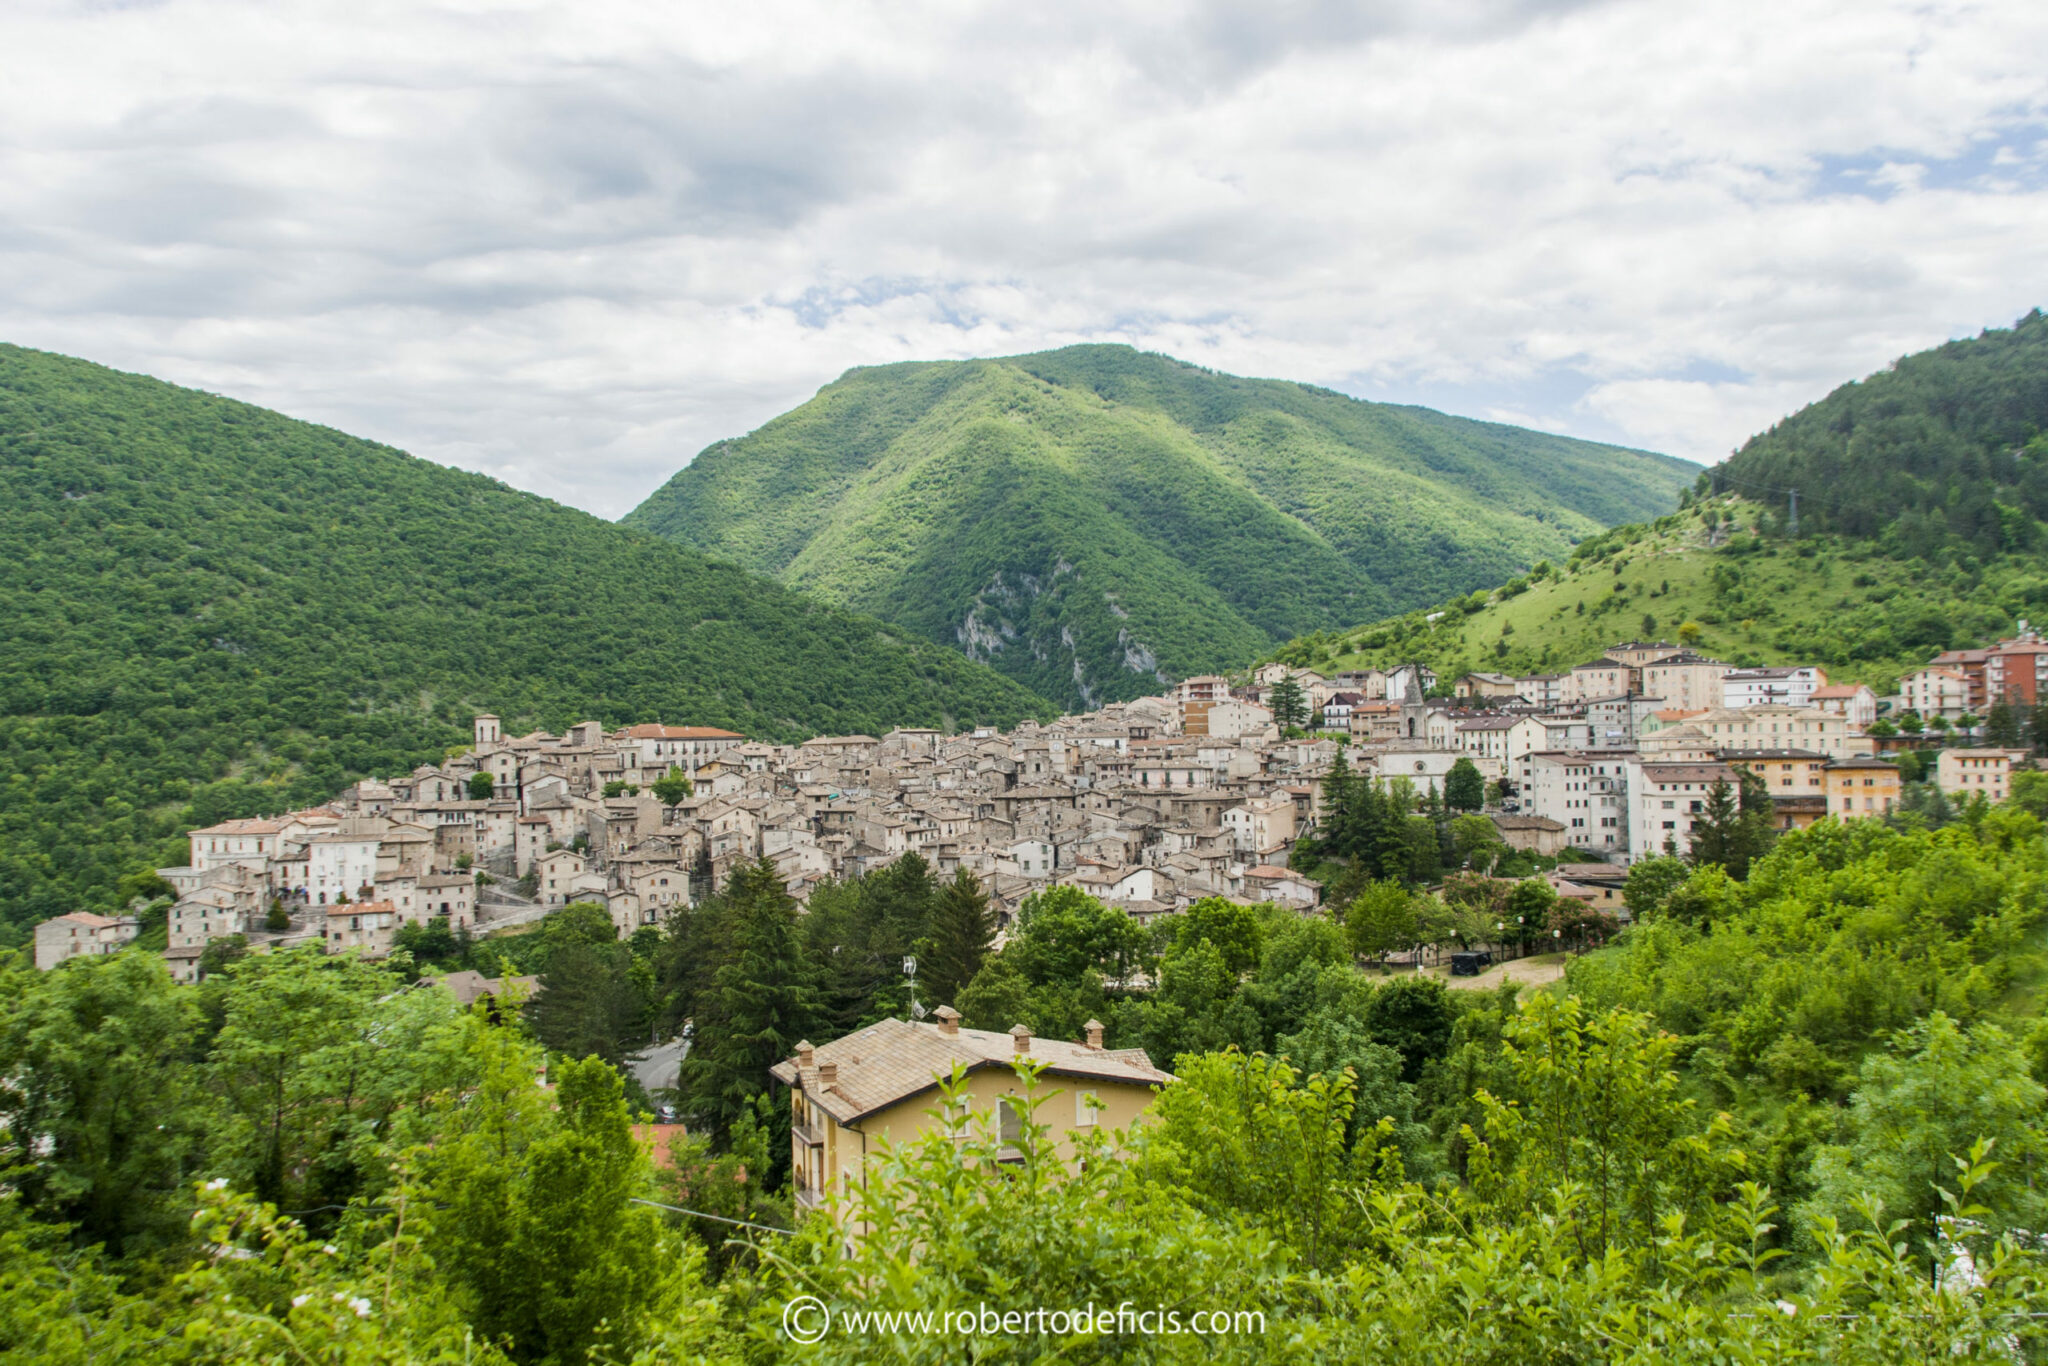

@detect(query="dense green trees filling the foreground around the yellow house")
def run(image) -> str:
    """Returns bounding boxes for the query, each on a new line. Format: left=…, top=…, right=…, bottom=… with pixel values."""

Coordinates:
left=0, top=776, right=2048, bottom=1366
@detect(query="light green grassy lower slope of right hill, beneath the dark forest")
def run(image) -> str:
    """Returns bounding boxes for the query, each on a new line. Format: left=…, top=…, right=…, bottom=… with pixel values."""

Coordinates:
left=1278, top=496, right=2048, bottom=692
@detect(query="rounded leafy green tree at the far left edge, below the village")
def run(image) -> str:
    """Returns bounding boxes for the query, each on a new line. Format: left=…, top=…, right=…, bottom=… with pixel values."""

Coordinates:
left=0, top=952, right=205, bottom=1255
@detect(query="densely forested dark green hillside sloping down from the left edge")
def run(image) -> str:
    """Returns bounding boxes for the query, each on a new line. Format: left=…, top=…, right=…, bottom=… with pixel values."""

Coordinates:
left=0, top=346, right=1047, bottom=926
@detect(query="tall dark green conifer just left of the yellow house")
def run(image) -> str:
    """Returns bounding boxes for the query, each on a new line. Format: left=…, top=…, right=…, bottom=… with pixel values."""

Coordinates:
left=682, top=858, right=819, bottom=1151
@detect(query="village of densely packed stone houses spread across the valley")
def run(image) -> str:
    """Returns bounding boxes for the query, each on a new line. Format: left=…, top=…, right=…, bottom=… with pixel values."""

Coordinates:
left=37, top=623, right=2048, bottom=981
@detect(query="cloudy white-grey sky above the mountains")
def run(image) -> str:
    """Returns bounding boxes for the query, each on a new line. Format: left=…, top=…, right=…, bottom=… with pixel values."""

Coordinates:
left=0, top=0, right=2048, bottom=516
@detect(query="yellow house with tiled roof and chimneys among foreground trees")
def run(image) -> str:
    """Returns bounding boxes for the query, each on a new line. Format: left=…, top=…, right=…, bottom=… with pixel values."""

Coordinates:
left=770, top=1006, right=1174, bottom=1210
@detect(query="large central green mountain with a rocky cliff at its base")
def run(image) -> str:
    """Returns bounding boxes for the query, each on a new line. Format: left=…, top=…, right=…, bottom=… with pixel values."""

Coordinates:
left=625, top=346, right=1698, bottom=705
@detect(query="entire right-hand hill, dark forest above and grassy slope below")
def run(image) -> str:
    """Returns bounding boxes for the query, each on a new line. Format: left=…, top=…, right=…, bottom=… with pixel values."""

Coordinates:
left=1276, top=311, right=2048, bottom=692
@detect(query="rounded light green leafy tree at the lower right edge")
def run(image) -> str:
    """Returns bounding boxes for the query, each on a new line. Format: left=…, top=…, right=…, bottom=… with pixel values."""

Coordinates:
left=1800, top=1012, right=2048, bottom=1241
